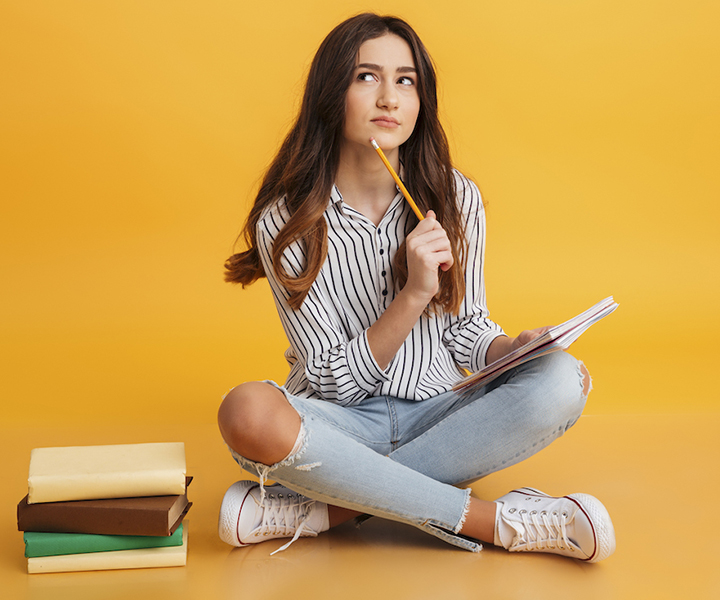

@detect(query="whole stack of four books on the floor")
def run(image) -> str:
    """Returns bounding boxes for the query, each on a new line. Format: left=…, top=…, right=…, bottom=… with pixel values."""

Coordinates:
left=17, top=442, right=192, bottom=573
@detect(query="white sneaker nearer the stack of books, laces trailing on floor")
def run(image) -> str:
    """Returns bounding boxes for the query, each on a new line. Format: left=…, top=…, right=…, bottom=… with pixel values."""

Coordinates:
left=218, top=481, right=329, bottom=554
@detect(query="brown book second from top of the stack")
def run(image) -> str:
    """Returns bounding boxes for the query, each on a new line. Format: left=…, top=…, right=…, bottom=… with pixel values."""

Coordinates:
left=17, top=477, right=192, bottom=536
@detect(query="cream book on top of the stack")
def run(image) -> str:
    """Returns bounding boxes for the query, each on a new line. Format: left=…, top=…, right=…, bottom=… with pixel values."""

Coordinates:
left=28, top=442, right=186, bottom=504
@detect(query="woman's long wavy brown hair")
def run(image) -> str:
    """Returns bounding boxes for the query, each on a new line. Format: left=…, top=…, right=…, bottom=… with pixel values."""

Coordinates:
left=225, top=13, right=467, bottom=313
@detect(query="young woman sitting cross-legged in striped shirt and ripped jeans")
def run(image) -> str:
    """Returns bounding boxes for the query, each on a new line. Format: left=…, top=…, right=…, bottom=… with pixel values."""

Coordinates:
left=218, top=14, right=615, bottom=562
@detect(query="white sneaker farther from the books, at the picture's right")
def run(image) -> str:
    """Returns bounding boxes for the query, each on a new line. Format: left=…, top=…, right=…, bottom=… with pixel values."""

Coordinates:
left=494, top=488, right=615, bottom=562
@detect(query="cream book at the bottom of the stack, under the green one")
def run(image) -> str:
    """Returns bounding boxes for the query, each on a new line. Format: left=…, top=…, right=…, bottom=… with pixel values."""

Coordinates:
left=28, top=521, right=188, bottom=573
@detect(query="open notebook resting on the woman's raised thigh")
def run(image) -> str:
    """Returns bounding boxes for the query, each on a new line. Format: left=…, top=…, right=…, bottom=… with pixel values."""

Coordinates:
left=453, top=296, right=618, bottom=394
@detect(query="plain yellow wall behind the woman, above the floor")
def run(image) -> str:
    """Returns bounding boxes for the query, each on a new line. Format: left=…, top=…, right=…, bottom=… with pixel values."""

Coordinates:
left=0, top=0, right=720, bottom=427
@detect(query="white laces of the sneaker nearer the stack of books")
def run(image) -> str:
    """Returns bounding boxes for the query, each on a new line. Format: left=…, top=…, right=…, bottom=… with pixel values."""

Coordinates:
left=250, top=493, right=317, bottom=556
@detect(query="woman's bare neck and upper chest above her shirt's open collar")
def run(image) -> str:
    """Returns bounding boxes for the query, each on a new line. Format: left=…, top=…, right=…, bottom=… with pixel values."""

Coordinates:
left=335, top=144, right=400, bottom=225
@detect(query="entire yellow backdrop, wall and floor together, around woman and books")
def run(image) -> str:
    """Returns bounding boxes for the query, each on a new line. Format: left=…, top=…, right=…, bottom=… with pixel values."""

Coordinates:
left=0, top=5, right=720, bottom=600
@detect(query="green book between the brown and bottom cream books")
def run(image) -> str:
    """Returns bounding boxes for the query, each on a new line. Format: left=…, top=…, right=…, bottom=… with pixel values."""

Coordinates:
left=23, top=525, right=183, bottom=558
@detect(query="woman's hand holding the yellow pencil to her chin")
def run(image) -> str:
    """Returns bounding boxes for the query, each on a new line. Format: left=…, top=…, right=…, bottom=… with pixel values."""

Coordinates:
left=404, top=210, right=453, bottom=305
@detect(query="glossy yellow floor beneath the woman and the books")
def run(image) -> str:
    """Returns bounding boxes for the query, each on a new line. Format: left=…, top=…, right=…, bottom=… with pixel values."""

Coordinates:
left=0, top=414, right=720, bottom=600
